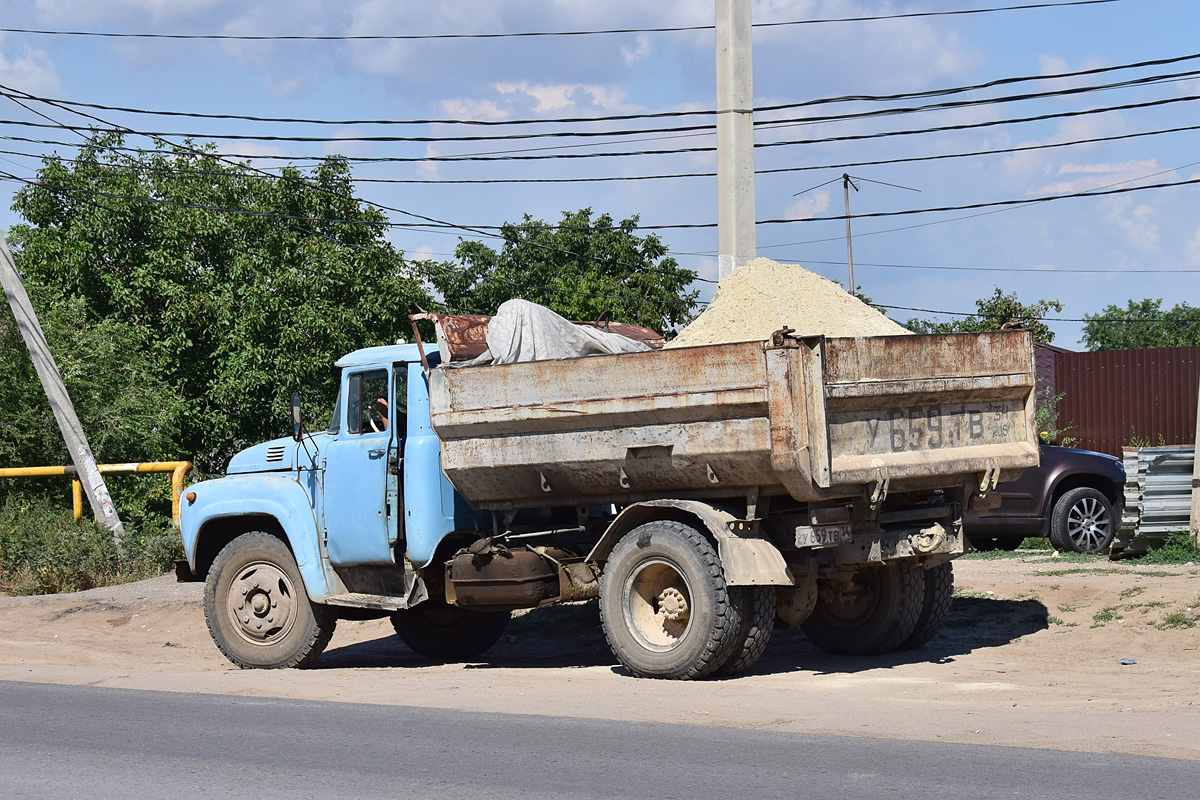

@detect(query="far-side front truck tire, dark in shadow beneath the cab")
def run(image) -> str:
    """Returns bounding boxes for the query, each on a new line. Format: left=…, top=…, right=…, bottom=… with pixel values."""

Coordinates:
left=391, top=596, right=510, bottom=661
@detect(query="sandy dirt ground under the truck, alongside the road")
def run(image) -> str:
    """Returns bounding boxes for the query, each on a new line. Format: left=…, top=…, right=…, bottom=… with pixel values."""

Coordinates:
left=0, top=554, right=1200, bottom=758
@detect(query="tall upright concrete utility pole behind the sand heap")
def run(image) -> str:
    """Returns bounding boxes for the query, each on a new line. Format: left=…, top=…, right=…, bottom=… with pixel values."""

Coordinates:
left=716, top=0, right=757, bottom=279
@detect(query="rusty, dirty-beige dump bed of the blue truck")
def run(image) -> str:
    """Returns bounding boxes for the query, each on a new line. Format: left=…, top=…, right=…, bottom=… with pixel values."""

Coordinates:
left=430, top=331, right=1038, bottom=509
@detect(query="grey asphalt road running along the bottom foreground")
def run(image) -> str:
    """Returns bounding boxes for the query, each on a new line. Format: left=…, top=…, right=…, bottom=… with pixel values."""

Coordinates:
left=0, top=676, right=1200, bottom=800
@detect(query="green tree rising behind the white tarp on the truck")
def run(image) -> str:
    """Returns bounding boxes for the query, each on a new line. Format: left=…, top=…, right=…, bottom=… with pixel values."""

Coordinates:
left=425, top=209, right=700, bottom=336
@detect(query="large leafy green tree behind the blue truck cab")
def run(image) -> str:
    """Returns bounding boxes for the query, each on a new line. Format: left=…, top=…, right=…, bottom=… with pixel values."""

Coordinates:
left=5, top=134, right=431, bottom=471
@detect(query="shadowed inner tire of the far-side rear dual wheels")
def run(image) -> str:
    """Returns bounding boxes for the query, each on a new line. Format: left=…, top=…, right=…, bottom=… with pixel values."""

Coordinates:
left=800, top=561, right=925, bottom=656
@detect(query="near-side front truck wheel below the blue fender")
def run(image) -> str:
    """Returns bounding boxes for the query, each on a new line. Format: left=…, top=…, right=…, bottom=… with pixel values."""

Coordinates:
left=204, top=530, right=337, bottom=669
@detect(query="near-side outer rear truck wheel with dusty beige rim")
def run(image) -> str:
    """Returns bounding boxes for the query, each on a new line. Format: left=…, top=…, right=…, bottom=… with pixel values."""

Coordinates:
left=600, top=521, right=743, bottom=680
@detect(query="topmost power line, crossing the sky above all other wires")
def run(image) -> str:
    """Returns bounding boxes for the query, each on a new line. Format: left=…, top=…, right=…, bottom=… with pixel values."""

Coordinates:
left=0, top=0, right=1120, bottom=42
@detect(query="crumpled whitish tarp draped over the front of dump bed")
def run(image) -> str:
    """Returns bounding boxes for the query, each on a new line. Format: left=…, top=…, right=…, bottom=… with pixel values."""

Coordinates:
left=445, top=300, right=652, bottom=367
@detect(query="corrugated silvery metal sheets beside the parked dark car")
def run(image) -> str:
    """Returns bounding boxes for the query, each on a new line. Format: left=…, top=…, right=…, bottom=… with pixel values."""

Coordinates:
left=1111, top=445, right=1195, bottom=558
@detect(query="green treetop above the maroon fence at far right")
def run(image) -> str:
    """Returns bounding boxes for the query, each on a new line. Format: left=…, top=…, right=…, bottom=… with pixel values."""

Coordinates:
left=1084, top=297, right=1200, bottom=350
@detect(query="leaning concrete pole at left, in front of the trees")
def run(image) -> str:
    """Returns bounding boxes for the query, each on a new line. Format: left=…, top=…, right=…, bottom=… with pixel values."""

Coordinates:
left=0, top=234, right=125, bottom=541
